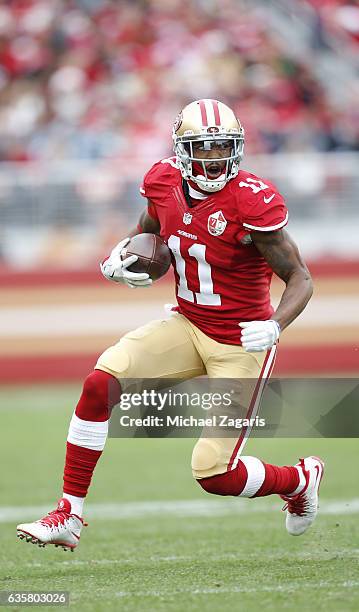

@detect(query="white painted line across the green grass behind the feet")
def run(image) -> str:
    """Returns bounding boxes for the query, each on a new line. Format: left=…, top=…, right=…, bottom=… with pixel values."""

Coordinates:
left=0, top=498, right=359, bottom=523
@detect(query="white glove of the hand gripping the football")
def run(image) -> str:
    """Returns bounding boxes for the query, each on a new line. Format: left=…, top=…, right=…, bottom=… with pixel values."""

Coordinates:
left=100, top=238, right=152, bottom=289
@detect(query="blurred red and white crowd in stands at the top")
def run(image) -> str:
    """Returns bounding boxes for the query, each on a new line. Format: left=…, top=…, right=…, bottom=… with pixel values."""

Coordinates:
left=0, top=0, right=359, bottom=161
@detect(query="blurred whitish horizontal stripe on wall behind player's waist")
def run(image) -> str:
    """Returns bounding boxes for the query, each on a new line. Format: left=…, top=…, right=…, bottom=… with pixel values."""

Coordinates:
left=0, top=295, right=359, bottom=338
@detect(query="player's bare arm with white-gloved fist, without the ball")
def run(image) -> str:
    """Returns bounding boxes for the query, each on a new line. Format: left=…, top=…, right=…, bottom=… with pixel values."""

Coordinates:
left=241, top=230, right=313, bottom=351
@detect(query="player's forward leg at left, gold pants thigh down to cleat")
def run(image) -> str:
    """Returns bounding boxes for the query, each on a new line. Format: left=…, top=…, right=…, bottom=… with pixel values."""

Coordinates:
left=18, top=316, right=204, bottom=550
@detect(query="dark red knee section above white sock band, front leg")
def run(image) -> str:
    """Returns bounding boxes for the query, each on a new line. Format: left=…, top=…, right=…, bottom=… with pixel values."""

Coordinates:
left=75, top=370, right=121, bottom=421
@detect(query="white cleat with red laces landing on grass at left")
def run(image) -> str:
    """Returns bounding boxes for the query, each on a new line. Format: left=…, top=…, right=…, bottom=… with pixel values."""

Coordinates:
left=17, top=498, right=87, bottom=551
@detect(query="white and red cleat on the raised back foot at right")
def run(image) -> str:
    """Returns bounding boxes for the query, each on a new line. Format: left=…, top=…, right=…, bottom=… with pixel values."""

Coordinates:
left=281, top=457, right=324, bottom=535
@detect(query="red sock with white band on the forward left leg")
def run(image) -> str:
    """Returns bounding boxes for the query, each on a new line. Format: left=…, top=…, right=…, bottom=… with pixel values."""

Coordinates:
left=63, top=370, right=121, bottom=497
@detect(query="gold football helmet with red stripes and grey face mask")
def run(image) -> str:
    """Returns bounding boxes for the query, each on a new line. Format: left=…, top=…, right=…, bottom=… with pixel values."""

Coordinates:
left=172, top=99, right=244, bottom=192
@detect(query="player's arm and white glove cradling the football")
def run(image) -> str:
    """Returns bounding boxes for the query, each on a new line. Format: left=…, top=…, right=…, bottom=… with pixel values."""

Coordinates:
left=100, top=201, right=160, bottom=289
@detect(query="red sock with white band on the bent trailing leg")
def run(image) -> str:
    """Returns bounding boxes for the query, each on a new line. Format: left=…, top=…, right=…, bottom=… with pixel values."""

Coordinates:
left=198, top=457, right=300, bottom=497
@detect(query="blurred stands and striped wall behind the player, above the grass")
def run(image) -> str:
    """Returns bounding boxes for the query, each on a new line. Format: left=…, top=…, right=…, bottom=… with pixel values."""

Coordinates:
left=0, top=0, right=359, bottom=384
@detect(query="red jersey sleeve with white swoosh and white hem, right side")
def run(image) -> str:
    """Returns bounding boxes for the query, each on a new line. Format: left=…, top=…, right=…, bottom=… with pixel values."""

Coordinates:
left=242, top=189, right=288, bottom=232
